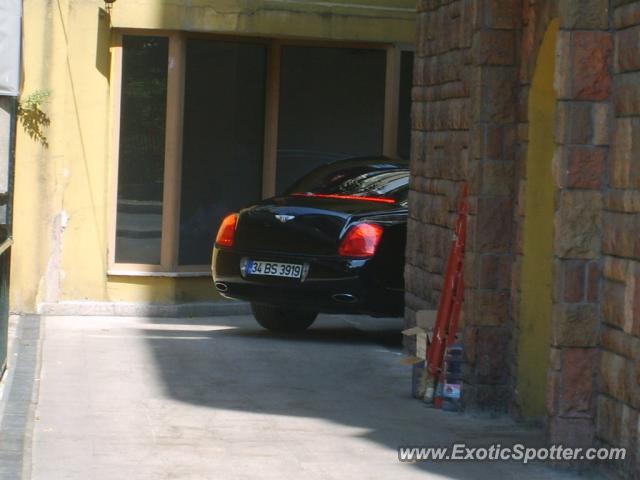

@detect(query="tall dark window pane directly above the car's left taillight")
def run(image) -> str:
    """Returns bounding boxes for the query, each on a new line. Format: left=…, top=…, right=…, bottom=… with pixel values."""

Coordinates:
left=179, top=39, right=266, bottom=265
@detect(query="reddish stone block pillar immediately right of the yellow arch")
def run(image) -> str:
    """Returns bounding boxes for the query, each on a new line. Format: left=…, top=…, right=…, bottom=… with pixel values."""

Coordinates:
left=547, top=0, right=613, bottom=445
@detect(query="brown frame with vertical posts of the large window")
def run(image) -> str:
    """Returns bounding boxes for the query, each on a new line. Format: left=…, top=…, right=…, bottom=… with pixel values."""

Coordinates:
left=107, top=29, right=414, bottom=277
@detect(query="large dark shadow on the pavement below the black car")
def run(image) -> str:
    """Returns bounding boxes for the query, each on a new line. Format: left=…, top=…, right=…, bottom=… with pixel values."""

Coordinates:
left=140, top=316, right=546, bottom=479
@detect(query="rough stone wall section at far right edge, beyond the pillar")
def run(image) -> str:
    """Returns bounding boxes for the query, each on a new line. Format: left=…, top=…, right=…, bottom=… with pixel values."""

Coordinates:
left=596, top=0, right=640, bottom=478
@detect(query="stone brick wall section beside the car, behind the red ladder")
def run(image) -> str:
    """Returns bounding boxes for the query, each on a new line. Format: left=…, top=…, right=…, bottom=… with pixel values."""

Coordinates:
left=405, top=0, right=472, bottom=394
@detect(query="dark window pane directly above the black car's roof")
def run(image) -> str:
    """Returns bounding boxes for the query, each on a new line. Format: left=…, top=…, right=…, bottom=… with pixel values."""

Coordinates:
left=276, top=47, right=386, bottom=192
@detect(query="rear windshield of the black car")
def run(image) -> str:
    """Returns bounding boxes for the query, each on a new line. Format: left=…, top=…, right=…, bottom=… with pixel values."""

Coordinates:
left=286, top=164, right=409, bottom=202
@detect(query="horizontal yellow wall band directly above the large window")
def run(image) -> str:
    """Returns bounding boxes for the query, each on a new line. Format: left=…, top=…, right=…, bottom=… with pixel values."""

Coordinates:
left=113, top=0, right=415, bottom=43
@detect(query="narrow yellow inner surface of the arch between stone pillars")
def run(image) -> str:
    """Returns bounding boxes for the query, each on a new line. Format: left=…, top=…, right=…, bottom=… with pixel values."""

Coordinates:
left=518, top=20, right=558, bottom=417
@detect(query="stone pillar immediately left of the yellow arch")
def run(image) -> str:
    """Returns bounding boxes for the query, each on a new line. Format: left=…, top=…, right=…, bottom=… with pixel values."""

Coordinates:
left=464, top=0, right=521, bottom=411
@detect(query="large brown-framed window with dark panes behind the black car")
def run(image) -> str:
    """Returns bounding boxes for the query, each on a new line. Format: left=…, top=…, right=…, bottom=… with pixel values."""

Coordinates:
left=109, top=32, right=412, bottom=275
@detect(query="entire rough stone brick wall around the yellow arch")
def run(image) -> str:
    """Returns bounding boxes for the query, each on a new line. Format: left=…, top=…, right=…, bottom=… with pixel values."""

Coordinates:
left=405, top=0, right=640, bottom=472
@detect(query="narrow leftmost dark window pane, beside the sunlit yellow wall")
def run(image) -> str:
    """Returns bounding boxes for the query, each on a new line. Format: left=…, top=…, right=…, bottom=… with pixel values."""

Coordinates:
left=115, top=36, right=169, bottom=264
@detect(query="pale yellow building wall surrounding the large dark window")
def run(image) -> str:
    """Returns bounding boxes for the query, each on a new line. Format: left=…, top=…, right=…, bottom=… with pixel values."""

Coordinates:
left=11, top=0, right=415, bottom=312
